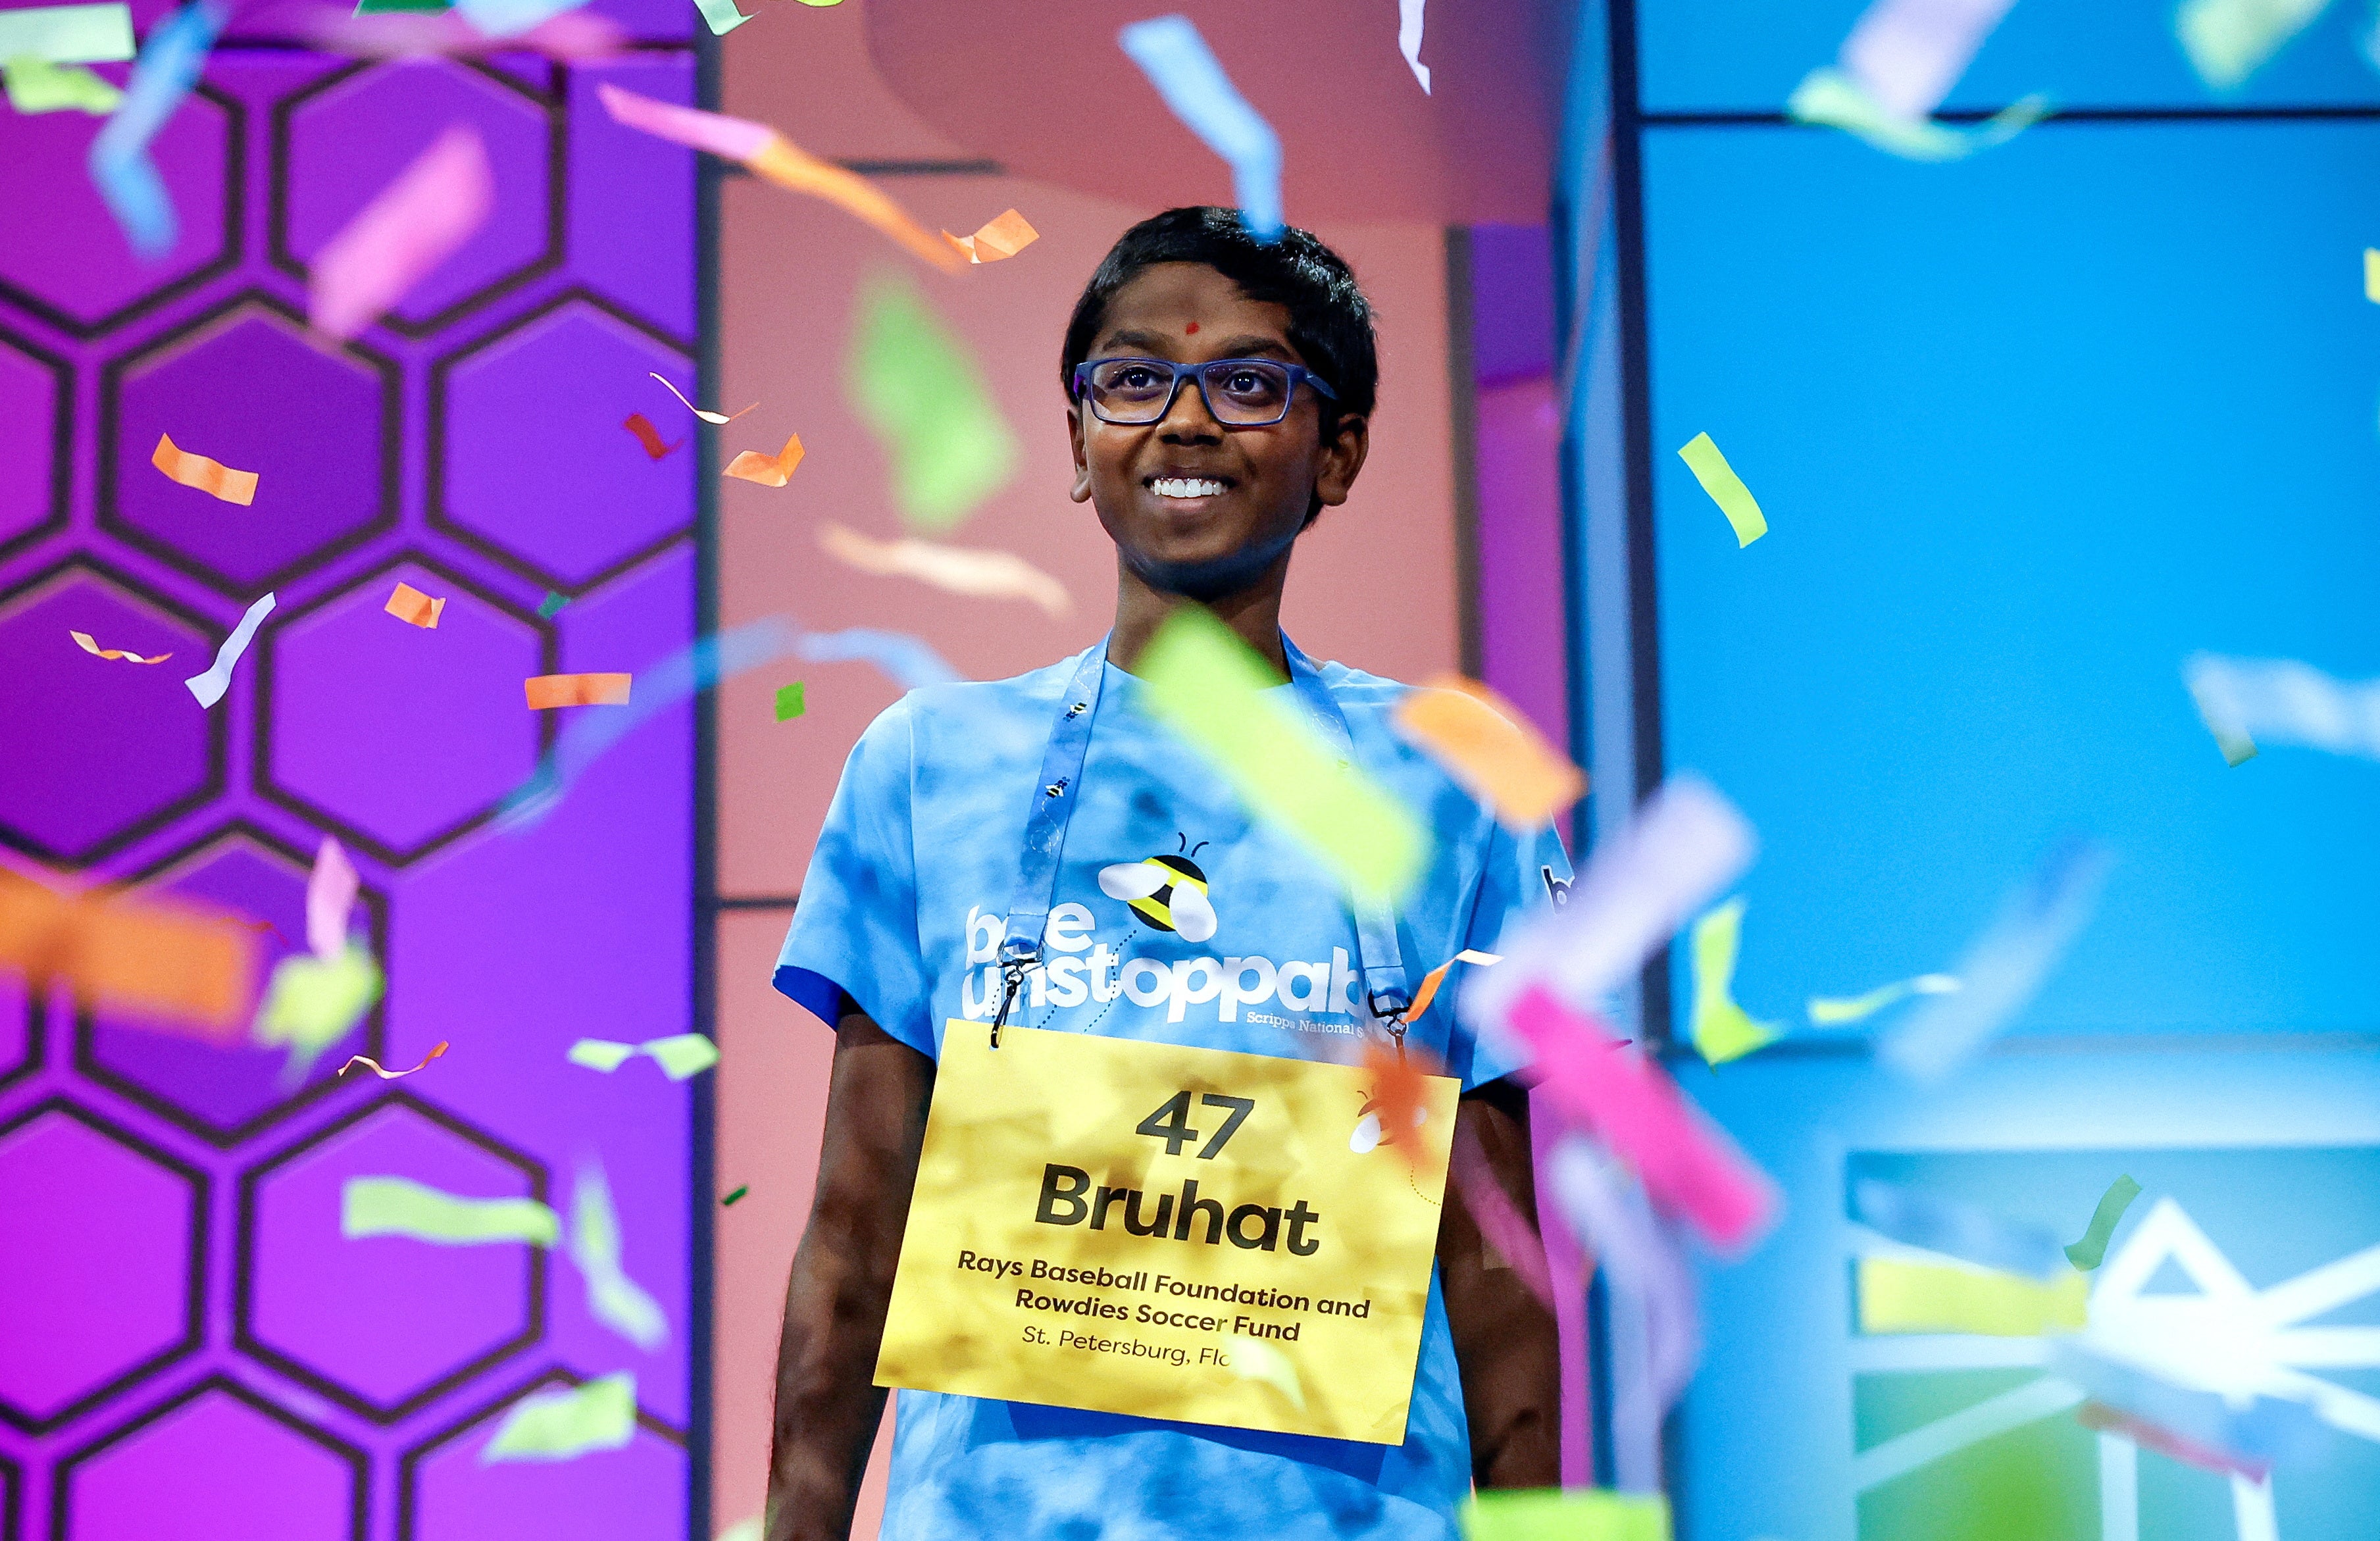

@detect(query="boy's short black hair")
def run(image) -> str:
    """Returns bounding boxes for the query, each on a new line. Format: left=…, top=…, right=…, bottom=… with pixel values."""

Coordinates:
left=1059, top=203, right=1380, bottom=438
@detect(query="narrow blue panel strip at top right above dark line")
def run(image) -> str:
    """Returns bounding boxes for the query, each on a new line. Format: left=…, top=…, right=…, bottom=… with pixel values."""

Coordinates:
left=1637, top=0, right=2380, bottom=112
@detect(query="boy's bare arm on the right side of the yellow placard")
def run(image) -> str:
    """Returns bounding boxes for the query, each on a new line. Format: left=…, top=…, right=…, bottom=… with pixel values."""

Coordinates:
left=1438, top=1081, right=1561, bottom=1488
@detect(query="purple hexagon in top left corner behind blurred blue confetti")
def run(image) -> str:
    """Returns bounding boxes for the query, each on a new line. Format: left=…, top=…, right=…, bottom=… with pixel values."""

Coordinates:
left=0, top=95, right=238, bottom=331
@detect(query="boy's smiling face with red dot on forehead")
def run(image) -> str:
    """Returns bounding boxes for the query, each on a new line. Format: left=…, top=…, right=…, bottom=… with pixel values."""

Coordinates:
left=1066, top=262, right=1366, bottom=598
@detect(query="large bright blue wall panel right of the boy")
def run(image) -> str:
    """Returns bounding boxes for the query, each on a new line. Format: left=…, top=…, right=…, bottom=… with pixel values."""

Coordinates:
left=1644, top=122, right=2380, bottom=1034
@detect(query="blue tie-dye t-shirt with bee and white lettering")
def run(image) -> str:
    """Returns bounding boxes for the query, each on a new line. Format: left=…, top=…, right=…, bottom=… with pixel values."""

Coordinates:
left=776, top=643, right=1571, bottom=1541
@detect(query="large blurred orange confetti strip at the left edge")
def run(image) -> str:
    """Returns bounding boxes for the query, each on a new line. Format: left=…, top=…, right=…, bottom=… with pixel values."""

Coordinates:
left=0, top=869, right=257, bottom=1041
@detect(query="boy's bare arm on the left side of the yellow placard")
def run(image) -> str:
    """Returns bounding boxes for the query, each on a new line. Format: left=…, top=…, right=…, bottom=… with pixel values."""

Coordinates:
left=767, top=998, right=933, bottom=1541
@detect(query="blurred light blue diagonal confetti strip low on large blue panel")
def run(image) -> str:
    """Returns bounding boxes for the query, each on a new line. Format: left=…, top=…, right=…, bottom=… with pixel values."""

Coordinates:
left=1878, top=841, right=2114, bottom=1081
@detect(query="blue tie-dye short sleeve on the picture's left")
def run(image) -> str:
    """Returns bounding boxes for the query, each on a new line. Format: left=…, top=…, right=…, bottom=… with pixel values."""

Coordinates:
left=776, top=700, right=935, bottom=1055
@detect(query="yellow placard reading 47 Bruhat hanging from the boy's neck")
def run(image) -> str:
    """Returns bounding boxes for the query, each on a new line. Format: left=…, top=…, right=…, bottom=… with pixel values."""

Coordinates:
left=876, top=1022, right=1459, bottom=1444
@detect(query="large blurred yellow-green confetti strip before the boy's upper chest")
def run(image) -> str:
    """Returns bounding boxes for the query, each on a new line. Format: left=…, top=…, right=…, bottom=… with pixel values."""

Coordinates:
left=1133, top=605, right=1428, bottom=896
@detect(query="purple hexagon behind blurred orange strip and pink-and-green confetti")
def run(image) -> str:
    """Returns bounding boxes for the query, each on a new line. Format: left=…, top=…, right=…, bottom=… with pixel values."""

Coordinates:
left=81, top=831, right=383, bottom=1138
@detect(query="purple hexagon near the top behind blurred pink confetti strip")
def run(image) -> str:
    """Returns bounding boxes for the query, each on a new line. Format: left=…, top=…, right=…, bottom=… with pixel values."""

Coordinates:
left=281, top=59, right=559, bottom=324
